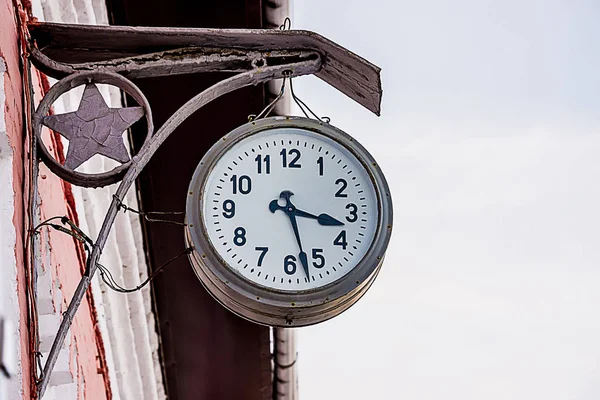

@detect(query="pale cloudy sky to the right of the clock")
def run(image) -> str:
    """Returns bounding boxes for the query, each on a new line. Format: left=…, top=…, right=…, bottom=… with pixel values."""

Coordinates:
left=293, top=0, right=600, bottom=400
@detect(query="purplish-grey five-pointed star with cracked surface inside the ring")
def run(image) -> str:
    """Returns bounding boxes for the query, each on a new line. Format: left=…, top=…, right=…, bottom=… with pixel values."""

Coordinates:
left=42, top=83, right=144, bottom=170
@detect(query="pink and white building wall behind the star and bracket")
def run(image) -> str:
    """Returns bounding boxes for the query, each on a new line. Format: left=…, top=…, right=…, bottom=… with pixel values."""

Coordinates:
left=0, top=0, right=165, bottom=400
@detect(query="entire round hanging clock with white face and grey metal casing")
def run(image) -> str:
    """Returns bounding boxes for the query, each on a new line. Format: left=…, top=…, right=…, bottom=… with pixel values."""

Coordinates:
left=185, top=117, right=392, bottom=326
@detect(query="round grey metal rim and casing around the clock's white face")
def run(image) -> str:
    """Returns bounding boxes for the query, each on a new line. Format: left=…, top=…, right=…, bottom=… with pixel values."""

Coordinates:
left=185, top=117, right=393, bottom=326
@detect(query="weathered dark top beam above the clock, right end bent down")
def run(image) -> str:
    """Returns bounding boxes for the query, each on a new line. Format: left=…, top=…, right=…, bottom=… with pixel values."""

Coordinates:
left=29, top=23, right=382, bottom=115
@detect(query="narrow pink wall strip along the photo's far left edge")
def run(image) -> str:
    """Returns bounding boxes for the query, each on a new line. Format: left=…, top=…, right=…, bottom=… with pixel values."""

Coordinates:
left=0, top=0, right=30, bottom=399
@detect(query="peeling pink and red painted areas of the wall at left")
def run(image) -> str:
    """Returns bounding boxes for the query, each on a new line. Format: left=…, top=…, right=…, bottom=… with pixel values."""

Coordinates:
left=0, top=0, right=121, bottom=400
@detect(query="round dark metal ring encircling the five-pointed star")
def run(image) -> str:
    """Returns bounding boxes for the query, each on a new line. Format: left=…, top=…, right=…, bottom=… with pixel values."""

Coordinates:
left=33, top=72, right=154, bottom=187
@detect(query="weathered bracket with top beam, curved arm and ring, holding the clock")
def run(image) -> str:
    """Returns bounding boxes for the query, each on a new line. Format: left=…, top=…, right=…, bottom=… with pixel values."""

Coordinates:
left=29, top=23, right=382, bottom=398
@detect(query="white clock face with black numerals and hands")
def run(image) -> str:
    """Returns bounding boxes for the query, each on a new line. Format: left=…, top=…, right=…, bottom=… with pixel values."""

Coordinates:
left=202, top=128, right=379, bottom=291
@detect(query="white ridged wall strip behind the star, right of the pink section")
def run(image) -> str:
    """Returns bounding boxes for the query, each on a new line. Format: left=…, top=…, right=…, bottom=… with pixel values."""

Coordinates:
left=32, top=0, right=165, bottom=400
